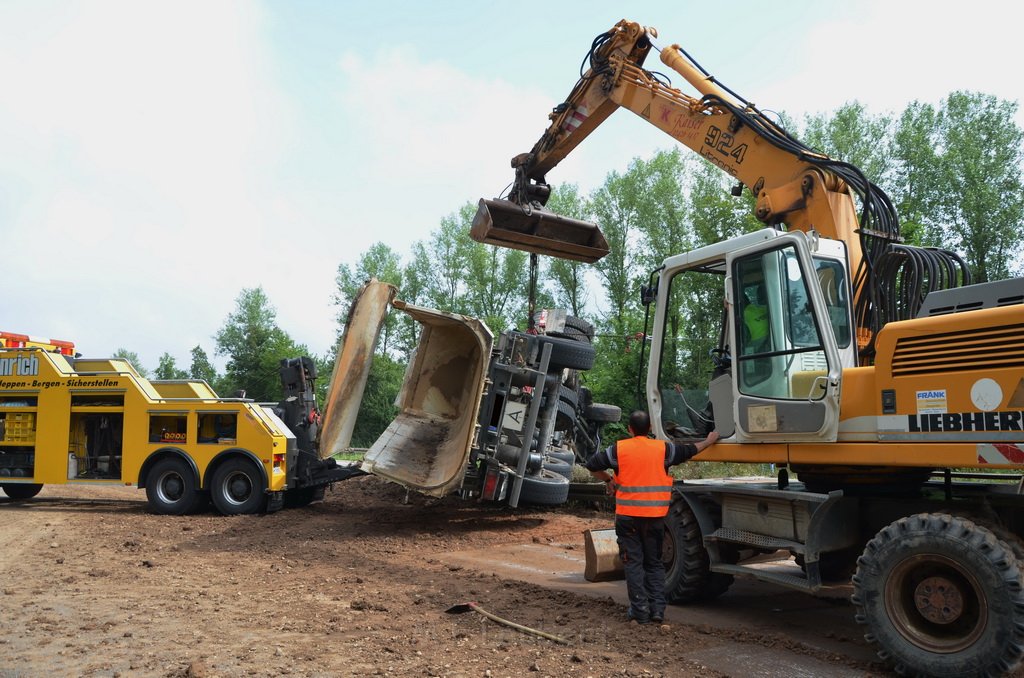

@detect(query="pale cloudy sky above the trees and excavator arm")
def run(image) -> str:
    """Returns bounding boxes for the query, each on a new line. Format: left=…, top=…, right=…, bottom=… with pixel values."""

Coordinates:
left=0, top=0, right=1024, bottom=370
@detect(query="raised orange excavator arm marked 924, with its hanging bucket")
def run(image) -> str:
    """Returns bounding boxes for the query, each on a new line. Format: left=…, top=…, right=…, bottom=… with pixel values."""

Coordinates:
left=472, top=19, right=963, bottom=360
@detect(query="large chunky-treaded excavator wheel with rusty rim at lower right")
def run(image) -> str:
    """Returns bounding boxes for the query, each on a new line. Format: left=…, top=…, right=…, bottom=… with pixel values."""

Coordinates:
left=851, top=513, right=1024, bottom=676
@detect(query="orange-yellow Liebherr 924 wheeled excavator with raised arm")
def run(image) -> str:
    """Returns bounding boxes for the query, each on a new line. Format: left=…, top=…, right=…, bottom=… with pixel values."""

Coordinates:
left=471, top=20, right=1024, bottom=676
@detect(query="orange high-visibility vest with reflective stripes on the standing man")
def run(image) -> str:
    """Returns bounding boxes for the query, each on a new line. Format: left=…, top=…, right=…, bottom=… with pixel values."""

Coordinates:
left=615, top=435, right=672, bottom=518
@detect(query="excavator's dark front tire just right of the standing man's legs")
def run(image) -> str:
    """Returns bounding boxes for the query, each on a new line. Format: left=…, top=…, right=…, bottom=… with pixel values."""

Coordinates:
left=663, top=495, right=732, bottom=603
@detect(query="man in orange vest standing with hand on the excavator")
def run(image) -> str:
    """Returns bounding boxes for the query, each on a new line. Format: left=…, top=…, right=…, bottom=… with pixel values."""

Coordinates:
left=587, top=410, right=719, bottom=624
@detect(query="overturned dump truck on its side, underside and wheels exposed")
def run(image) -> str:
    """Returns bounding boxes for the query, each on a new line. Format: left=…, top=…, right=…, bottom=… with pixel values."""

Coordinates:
left=319, top=281, right=622, bottom=507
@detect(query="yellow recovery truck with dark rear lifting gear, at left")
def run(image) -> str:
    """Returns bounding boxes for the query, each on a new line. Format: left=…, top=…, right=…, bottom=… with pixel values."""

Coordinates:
left=0, top=333, right=361, bottom=515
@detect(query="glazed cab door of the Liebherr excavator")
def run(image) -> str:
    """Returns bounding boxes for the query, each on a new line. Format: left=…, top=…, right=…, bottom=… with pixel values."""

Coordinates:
left=726, top=231, right=842, bottom=442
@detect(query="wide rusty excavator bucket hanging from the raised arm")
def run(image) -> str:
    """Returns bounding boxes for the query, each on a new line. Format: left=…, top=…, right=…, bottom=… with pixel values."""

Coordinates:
left=469, top=200, right=608, bottom=263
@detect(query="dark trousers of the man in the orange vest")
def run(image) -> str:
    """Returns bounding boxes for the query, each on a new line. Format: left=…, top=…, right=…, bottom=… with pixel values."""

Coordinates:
left=615, top=515, right=665, bottom=622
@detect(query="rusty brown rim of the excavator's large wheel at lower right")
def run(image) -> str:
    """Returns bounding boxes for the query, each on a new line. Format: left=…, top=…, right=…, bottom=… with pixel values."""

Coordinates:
left=885, top=553, right=988, bottom=653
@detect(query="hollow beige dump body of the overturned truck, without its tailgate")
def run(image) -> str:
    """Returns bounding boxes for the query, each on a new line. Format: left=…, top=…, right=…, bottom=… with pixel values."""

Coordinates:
left=362, top=301, right=494, bottom=497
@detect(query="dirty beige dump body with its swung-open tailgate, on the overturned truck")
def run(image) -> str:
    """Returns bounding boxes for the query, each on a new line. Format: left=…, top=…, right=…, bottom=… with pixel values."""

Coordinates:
left=321, top=281, right=494, bottom=497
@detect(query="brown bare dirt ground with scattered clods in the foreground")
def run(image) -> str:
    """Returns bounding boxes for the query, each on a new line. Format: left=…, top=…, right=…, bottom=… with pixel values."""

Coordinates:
left=0, top=477, right=879, bottom=678
